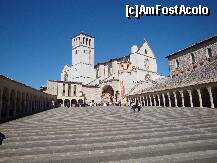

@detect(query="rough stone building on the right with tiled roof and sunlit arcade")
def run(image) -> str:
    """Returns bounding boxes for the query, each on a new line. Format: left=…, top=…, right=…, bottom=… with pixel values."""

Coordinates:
left=127, top=36, right=217, bottom=108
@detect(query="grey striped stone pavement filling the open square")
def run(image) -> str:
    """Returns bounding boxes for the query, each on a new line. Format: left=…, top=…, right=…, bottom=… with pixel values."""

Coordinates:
left=0, top=107, right=217, bottom=163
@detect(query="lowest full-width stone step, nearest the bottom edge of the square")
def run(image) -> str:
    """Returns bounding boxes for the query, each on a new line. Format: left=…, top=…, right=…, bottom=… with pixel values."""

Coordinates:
left=0, top=139, right=217, bottom=163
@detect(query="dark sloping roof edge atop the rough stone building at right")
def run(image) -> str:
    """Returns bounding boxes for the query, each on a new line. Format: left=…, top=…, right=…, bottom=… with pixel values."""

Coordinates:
left=166, top=35, right=217, bottom=59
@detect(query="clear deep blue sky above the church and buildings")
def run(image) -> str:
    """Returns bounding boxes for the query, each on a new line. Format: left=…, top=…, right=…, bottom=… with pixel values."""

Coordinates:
left=0, top=0, right=217, bottom=88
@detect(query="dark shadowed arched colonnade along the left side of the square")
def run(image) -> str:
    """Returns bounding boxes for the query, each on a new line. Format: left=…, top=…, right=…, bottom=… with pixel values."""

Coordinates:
left=0, top=76, right=56, bottom=122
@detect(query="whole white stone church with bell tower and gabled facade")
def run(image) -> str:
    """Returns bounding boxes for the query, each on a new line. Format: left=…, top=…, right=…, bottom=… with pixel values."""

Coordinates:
left=45, top=33, right=164, bottom=106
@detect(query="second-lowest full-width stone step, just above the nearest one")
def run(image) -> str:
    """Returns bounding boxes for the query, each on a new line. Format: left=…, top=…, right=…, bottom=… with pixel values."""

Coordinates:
left=0, top=134, right=217, bottom=158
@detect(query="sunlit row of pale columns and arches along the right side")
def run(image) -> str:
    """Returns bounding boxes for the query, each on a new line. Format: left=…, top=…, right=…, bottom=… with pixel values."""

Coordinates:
left=128, top=84, right=217, bottom=108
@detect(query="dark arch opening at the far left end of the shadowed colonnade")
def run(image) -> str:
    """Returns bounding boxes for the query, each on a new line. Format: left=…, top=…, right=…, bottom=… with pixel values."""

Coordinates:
left=1, top=88, right=9, bottom=119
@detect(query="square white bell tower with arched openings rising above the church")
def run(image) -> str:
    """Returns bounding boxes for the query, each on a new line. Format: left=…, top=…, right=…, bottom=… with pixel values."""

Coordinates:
left=72, top=33, right=94, bottom=67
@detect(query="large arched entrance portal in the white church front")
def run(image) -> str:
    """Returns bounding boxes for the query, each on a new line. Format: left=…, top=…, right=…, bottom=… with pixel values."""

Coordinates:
left=101, top=85, right=114, bottom=102
